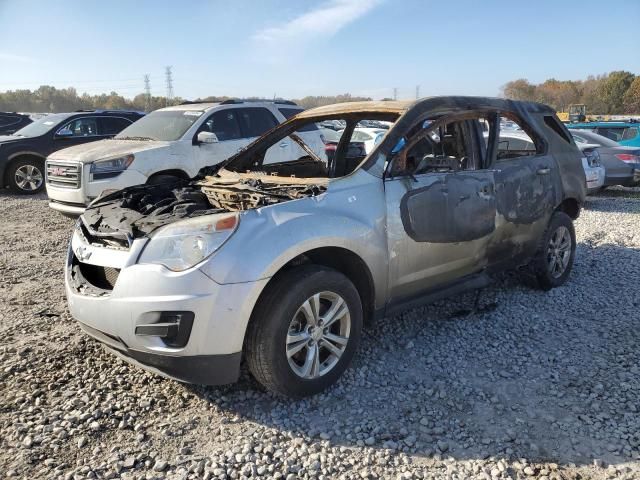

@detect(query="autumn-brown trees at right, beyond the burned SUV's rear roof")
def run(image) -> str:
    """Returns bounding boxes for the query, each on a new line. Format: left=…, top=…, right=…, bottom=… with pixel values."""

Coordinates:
left=502, top=70, right=640, bottom=115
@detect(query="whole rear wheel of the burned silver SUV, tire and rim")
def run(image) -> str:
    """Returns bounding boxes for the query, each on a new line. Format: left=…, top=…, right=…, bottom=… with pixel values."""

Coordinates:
left=534, top=212, right=576, bottom=290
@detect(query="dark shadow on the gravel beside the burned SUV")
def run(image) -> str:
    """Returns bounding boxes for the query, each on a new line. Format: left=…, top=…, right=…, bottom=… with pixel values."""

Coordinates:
left=188, top=244, right=640, bottom=465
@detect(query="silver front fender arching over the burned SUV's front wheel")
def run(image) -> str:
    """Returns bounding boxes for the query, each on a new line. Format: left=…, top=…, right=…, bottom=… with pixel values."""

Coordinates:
left=201, top=170, right=388, bottom=308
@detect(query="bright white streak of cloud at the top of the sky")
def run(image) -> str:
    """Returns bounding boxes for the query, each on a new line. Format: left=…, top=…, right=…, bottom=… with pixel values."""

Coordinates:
left=252, top=0, right=382, bottom=58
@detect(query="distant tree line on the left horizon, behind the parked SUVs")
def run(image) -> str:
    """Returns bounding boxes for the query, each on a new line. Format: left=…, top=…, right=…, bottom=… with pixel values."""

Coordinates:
left=0, top=85, right=371, bottom=113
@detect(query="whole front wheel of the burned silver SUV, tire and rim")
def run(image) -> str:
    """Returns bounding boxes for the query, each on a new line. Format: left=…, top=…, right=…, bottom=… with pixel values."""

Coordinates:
left=245, top=265, right=362, bottom=398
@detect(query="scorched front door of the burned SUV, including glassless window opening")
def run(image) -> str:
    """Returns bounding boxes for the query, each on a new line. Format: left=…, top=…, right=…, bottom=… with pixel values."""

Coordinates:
left=385, top=118, right=496, bottom=303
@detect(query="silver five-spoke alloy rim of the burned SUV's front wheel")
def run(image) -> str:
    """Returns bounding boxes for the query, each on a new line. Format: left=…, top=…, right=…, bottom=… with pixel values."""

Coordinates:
left=285, top=291, right=351, bottom=380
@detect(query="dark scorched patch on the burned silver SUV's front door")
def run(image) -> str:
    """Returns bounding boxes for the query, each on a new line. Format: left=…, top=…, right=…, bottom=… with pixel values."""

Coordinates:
left=400, top=172, right=496, bottom=243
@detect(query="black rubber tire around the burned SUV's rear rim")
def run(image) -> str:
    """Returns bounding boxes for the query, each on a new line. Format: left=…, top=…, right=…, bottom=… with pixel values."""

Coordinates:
left=533, top=212, right=576, bottom=290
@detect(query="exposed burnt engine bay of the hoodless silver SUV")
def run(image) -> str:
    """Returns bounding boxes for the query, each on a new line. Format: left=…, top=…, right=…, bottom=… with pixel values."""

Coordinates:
left=83, top=169, right=328, bottom=240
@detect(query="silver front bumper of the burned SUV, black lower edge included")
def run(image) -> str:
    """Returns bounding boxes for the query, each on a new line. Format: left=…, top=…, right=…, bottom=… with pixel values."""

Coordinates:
left=65, top=231, right=267, bottom=385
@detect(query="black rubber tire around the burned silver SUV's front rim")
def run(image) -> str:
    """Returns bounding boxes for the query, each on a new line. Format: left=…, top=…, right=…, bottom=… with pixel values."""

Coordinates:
left=245, top=265, right=362, bottom=398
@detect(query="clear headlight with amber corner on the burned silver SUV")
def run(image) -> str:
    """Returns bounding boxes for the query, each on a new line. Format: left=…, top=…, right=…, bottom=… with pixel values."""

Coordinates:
left=138, top=213, right=240, bottom=272
